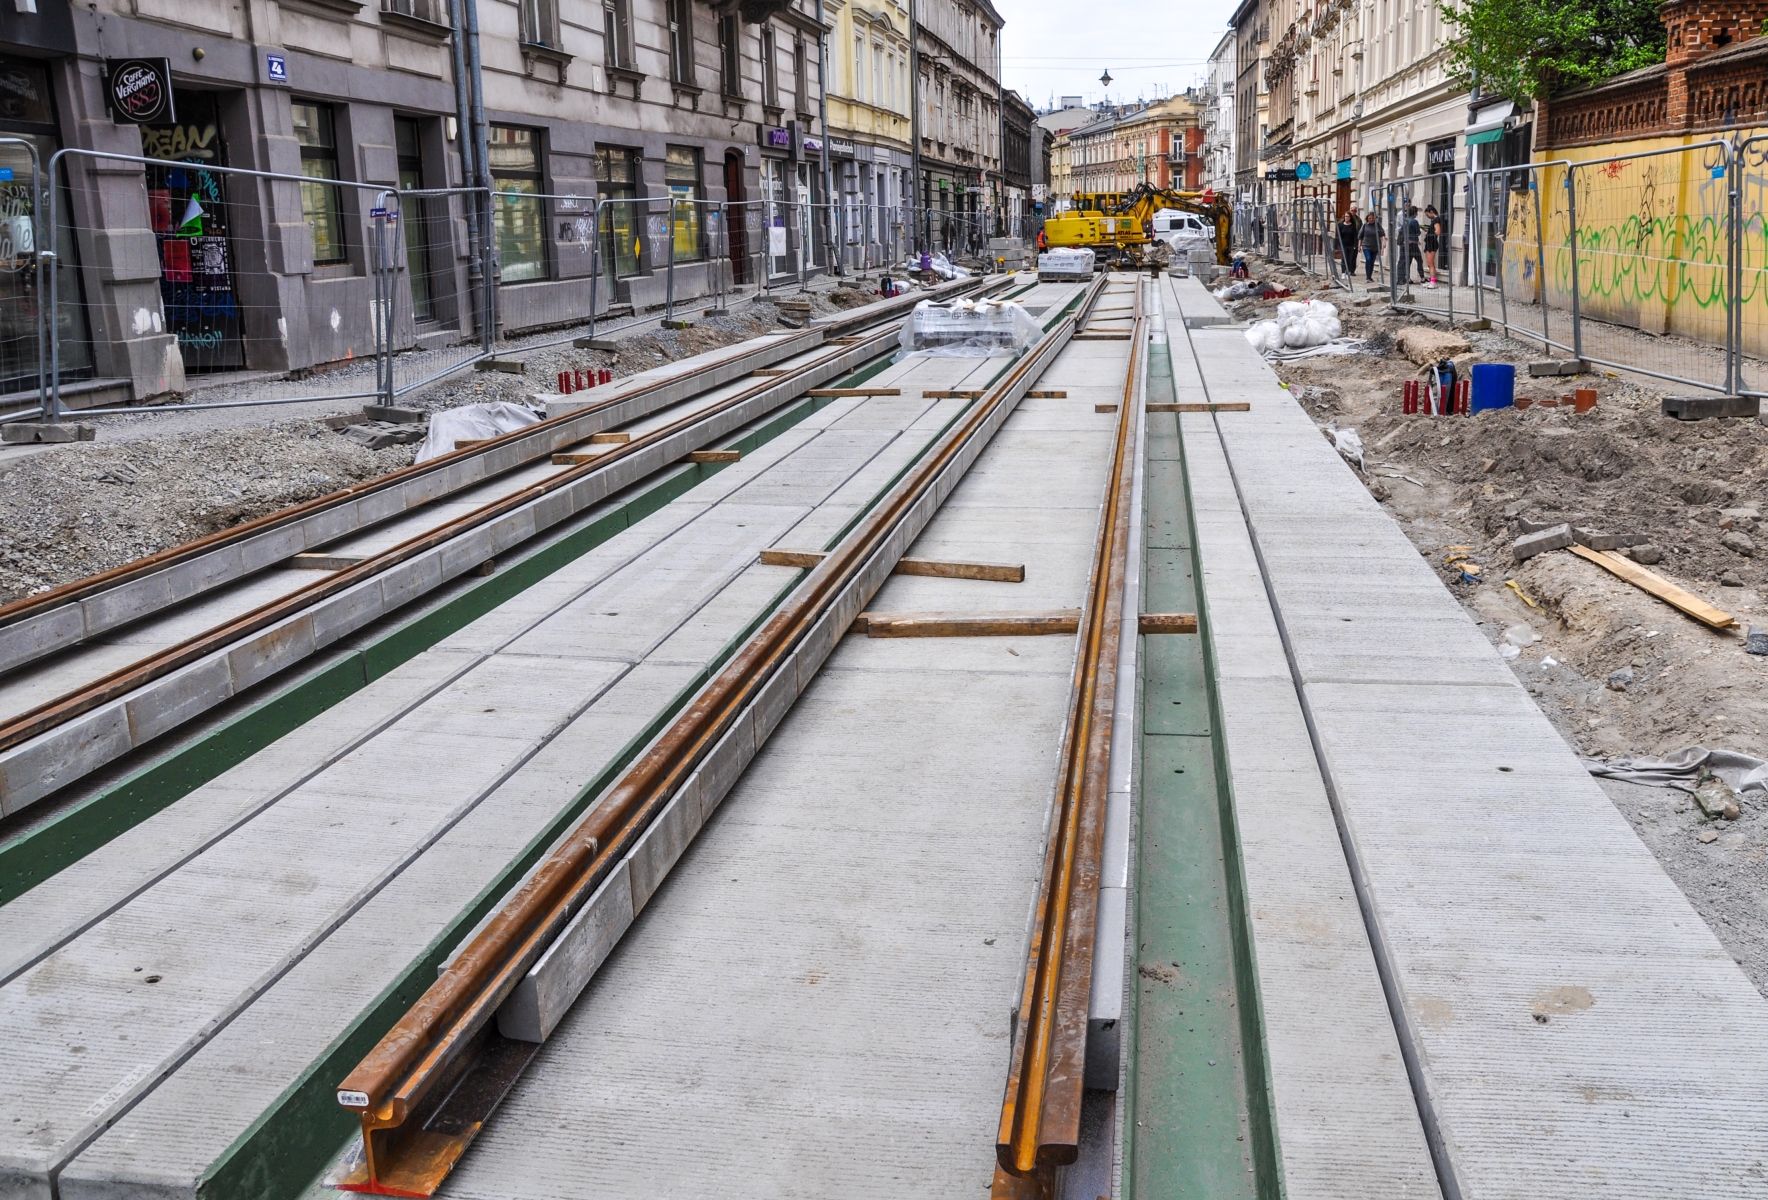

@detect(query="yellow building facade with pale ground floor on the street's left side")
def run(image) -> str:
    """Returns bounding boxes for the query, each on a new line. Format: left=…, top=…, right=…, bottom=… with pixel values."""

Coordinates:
left=824, top=0, right=914, bottom=267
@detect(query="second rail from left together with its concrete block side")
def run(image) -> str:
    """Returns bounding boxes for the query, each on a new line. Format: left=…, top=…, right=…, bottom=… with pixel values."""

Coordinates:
left=0, top=281, right=999, bottom=827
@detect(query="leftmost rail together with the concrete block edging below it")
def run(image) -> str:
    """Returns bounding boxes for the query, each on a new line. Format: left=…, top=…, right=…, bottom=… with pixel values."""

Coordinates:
left=0, top=276, right=1010, bottom=685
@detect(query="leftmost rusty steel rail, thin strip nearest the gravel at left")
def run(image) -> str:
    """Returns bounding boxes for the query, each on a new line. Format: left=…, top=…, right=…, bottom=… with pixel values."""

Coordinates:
left=0, top=277, right=1001, bottom=668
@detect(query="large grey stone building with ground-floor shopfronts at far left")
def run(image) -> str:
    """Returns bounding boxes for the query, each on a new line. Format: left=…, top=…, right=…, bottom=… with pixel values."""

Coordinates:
left=0, top=0, right=823, bottom=403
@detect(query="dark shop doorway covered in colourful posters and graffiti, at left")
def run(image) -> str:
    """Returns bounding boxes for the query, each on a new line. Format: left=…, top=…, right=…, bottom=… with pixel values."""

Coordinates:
left=141, top=92, right=246, bottom=373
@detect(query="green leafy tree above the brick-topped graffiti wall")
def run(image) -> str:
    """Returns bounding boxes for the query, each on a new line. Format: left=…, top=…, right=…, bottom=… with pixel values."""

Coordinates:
left=1437, top=0, right=1664, bottom=103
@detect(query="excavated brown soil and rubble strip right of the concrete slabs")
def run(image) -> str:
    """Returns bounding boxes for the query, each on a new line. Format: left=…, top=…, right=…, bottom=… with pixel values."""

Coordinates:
left=1229, top=263, right=1768, bottom=993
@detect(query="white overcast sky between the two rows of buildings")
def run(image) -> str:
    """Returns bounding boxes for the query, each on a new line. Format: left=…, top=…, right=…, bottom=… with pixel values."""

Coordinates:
left=995, top=0, right=1238, bottom=110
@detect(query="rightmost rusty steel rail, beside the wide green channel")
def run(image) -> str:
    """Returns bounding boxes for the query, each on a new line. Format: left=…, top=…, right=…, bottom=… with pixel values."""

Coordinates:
left=994, top=279, right=1147, bottom=1198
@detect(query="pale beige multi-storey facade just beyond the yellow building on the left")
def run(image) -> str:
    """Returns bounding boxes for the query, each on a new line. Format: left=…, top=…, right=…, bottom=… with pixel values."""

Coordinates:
left=916, top=0, right=1004, bottom=253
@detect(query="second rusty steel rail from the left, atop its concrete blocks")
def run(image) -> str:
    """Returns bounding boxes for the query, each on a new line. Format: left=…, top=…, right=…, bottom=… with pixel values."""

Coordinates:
left=0, top=314, right=926, bottom=751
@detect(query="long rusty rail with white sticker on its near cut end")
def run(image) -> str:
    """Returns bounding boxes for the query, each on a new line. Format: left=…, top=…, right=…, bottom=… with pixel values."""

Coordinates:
left=328, top=276, right=1105, bottom=1196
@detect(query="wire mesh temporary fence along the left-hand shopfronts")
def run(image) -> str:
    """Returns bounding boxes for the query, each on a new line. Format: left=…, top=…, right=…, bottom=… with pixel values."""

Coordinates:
left=13, top=145, right=1025, bottom=419
